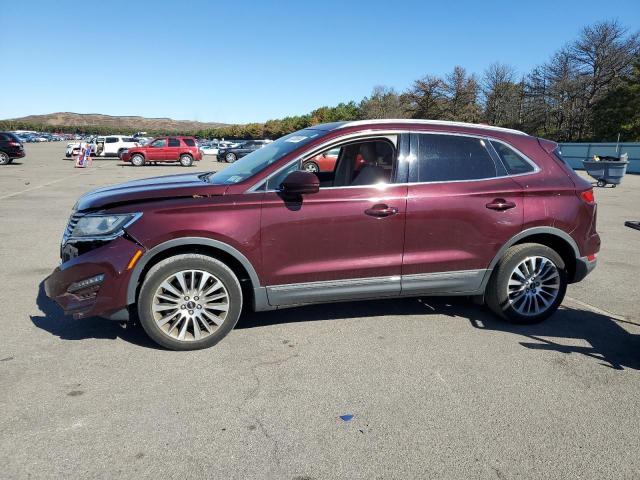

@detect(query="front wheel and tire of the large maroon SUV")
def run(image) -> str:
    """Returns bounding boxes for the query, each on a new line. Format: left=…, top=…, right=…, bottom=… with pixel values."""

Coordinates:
left=138, top=254, right=242, bottom=350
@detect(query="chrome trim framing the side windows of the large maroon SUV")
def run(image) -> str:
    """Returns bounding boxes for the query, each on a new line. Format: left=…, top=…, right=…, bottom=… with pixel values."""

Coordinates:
left=245, top=130, right=542, bottom=193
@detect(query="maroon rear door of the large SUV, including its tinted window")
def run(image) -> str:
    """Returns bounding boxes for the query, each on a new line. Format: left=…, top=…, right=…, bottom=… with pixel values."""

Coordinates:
left=402, top=133, right=524, bottom=294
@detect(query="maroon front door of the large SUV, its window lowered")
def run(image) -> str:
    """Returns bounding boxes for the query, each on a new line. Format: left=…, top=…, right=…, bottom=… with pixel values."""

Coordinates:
left=261, top=136, right=407, bottom=305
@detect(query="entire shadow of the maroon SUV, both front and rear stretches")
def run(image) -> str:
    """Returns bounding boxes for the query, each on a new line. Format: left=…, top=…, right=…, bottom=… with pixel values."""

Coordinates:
left=31, top=281, right=640, bottom=370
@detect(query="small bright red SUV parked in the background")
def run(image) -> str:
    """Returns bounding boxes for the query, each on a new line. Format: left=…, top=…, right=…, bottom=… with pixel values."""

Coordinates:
left=120, top=137, right=202, bottom=167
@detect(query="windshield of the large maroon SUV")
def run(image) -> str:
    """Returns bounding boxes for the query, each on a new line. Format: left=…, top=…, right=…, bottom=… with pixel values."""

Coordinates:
left=209, top=128, right=326, bottom=185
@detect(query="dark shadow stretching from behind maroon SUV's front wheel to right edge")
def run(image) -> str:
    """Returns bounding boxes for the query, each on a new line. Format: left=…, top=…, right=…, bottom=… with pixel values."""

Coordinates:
left=236, top=297, right=640, bottom=370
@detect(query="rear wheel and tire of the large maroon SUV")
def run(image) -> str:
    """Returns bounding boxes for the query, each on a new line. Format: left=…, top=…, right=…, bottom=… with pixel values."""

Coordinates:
left=485, top=243, right=567, bottom=324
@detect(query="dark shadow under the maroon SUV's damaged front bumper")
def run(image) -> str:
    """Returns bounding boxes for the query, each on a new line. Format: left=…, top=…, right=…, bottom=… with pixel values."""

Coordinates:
left=31, top=281, right=162, bottom=350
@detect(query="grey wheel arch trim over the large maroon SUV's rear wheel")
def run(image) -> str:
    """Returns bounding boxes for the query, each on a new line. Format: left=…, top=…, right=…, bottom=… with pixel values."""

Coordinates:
left=482, top=227, right=580, bottom=290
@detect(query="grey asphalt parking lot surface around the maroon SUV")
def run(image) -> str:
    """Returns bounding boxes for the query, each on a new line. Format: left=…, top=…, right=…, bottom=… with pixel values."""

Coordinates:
left=0, top=143, right=640, bottom=480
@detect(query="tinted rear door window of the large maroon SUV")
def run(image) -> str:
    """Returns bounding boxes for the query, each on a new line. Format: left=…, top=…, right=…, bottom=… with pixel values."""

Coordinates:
left=409, top=134, right=502, bottom=182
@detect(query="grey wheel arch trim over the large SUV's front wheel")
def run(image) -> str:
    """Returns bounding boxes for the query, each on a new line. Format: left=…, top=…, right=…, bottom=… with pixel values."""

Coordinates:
left=127, top=237, right=261, bottom=305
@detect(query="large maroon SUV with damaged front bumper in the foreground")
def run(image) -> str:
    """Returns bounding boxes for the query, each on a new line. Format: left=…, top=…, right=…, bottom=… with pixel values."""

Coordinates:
left=45, top=120, right=600, bottom=350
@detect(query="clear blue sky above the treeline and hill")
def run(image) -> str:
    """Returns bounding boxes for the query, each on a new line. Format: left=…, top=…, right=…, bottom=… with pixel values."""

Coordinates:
left=0, top=0, right=640, bottom=123
